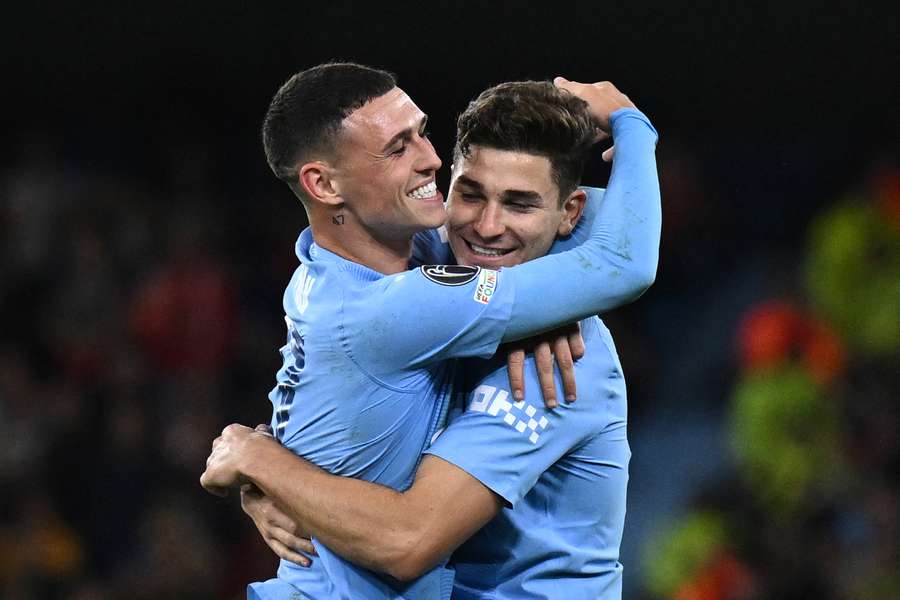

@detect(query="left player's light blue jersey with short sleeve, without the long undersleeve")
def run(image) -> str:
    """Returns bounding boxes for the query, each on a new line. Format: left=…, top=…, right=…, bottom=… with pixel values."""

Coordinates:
left=270, top=229, right=512, bottom=599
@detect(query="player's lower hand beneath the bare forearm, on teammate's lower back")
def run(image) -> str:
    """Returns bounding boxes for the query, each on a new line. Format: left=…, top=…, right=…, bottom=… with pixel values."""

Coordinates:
left=241, top=484, right=316, bottom=567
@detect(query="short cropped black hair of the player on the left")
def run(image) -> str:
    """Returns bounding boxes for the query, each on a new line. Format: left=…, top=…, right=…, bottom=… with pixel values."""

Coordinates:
left=262, top=62, right=397, bottom=198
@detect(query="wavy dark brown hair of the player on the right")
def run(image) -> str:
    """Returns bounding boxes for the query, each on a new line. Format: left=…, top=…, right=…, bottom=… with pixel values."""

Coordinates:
left=453, top=81, right=597, bottom=201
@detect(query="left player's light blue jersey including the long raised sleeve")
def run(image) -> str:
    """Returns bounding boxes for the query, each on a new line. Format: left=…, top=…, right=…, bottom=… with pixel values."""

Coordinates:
left=248, top=109, right=660, bottom=600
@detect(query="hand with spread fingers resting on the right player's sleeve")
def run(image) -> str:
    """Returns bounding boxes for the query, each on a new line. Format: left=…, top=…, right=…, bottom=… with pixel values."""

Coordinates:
left=506, top=323, right=584, bottom=408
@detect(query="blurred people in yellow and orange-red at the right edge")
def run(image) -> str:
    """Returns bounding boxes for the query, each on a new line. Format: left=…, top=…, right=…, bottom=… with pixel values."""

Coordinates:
left=644, top=167, right=900, bottom=600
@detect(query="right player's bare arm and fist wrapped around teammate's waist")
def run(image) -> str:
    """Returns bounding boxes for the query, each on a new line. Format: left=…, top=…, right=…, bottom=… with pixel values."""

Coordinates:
left=201, top=425, right=503, bottom=581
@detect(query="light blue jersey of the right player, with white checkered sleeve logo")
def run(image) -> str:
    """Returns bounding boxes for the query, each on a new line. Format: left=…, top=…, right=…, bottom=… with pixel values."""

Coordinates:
left=427, top=317, right=631, bottom=600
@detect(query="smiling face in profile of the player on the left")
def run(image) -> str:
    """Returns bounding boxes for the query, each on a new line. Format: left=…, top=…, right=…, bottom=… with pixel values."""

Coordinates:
left=333, top=88, right=446, bottom=239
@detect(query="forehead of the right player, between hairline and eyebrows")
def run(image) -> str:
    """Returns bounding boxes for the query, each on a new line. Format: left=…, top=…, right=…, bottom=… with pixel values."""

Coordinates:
left=453, top=146, right=559, bottom=202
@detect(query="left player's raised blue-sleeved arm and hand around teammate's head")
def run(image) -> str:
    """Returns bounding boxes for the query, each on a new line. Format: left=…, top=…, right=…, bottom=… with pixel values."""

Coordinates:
left=358, top=84, right=661, bottom=376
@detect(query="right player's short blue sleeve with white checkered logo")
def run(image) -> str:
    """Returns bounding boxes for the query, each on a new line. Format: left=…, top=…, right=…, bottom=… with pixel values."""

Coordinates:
left=425, top=358, right=603, bottom=507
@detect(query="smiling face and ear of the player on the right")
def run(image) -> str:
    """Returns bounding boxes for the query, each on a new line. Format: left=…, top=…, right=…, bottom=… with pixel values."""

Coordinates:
left=447, top=146, right=585, bottom=269
